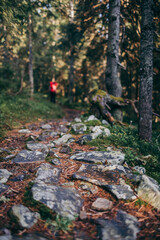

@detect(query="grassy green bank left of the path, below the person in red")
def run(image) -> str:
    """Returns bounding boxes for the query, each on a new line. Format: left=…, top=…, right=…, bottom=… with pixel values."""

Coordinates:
left=0, top=94, right=63, bottom=138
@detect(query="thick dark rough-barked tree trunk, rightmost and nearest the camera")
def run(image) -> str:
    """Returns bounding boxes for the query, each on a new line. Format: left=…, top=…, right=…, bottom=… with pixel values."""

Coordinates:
left=139, top=0, right=153, bottom=141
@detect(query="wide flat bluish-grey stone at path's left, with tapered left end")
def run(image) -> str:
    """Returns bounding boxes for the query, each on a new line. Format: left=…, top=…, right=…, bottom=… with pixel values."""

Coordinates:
left=12, top=150, right=47, bottom=163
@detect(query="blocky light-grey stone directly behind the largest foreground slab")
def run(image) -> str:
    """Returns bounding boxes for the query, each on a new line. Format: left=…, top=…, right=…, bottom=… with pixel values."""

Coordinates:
left=34, top=163, right=61, bottom=184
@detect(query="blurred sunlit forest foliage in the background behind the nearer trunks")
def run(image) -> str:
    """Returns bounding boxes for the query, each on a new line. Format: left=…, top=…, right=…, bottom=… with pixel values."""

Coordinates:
left=0, top=0, right=160, bottom=129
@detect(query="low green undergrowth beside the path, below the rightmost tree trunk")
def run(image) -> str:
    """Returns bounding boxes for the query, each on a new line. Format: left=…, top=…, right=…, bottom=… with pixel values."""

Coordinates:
left=88, top=125, right=160, bottom=183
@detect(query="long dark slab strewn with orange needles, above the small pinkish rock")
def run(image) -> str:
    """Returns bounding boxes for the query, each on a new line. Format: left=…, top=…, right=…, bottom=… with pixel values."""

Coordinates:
left=72, top=164, right=136, bottom=200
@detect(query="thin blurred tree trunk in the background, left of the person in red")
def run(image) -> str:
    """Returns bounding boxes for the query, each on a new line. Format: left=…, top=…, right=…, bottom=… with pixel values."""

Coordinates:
left=28, top=14, right=34, bottom=98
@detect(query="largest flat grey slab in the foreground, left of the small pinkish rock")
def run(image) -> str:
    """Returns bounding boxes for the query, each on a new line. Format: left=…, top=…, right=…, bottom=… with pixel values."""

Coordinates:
left=32, top=184, right=83, bottom=220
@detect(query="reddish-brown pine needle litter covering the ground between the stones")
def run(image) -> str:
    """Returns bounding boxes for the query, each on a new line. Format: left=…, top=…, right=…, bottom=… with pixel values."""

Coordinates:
left=0, top=109, right=160, bottom=240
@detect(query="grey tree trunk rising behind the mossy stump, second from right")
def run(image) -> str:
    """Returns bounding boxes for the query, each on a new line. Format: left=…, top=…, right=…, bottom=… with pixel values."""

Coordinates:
left=106, top=0, right=122, bottom=120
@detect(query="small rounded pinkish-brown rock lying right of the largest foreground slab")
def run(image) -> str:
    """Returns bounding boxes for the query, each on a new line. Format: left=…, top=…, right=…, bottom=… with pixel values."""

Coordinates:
left=91, top=198, right=113, bottom=211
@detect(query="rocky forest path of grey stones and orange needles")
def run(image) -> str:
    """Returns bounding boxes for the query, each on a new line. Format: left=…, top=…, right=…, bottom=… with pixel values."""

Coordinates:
left=0, top=116, right=160, bottom=240
